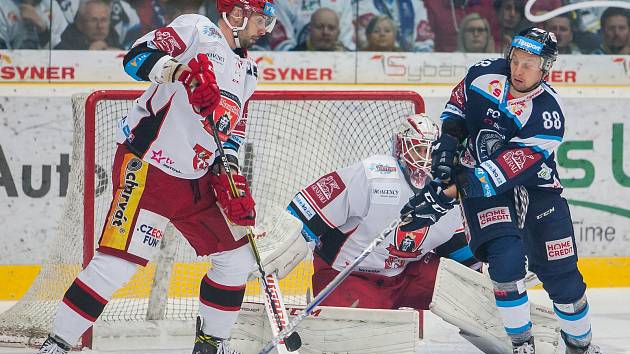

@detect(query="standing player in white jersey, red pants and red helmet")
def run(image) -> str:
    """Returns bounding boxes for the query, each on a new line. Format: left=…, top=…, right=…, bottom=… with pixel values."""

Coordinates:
left=40, top=0, right=275, bottom=354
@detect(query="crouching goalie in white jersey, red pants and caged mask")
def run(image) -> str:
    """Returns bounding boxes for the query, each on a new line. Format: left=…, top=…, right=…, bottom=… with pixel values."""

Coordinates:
left=288, top=115, right=480, bottom=310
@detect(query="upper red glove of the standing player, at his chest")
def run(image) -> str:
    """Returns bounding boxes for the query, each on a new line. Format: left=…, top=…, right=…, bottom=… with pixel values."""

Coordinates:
left=178, top=53, right=221, bottom=117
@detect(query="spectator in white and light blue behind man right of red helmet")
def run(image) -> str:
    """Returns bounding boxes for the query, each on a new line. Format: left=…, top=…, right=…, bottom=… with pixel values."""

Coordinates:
left=270, top=0, right=356, bottom=50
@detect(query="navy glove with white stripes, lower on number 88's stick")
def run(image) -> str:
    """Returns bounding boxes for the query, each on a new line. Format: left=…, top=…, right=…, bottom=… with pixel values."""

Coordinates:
left=400, top=181, right=455, bottom=231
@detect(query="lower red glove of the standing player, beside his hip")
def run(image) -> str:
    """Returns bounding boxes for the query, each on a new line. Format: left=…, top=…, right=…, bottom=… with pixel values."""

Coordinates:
left=210, top=173, right=256, bottom=226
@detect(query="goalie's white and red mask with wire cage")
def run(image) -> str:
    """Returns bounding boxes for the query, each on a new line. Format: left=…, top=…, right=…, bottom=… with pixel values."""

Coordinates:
left=394, top=113, right=440, bottom=188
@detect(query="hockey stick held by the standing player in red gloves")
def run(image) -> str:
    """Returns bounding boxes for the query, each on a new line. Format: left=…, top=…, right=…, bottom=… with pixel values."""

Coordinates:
left=206, top=116, right=302, bottom=352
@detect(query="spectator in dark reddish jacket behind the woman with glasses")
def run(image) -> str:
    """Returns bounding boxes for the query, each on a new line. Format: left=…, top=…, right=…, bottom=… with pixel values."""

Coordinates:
left=424, top=0, right=497, bottom=52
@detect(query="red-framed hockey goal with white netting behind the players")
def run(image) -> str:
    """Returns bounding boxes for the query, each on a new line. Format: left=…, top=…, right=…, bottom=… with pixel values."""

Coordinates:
left=0, top=90, right=424, bottom=345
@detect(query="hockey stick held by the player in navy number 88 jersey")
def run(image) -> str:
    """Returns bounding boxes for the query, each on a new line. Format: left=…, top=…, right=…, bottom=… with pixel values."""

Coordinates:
left=259, top=218, right=401, bottom=354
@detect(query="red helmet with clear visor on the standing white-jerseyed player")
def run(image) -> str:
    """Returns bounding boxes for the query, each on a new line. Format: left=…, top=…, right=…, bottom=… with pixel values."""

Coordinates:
left=217, top=0, right=276, bottom=48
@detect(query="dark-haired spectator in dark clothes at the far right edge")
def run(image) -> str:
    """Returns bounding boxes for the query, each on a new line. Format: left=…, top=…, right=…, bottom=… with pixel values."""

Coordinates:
left=593, top=7, right=630, bottom=55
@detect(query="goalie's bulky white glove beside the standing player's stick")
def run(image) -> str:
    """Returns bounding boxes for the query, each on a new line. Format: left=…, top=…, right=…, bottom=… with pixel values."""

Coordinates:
left=249, top=208, right=310, bottom=280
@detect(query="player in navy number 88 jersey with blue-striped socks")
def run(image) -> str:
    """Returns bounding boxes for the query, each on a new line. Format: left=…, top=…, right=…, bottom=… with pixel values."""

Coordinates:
left=403, top=28, right=601, bottom=354
